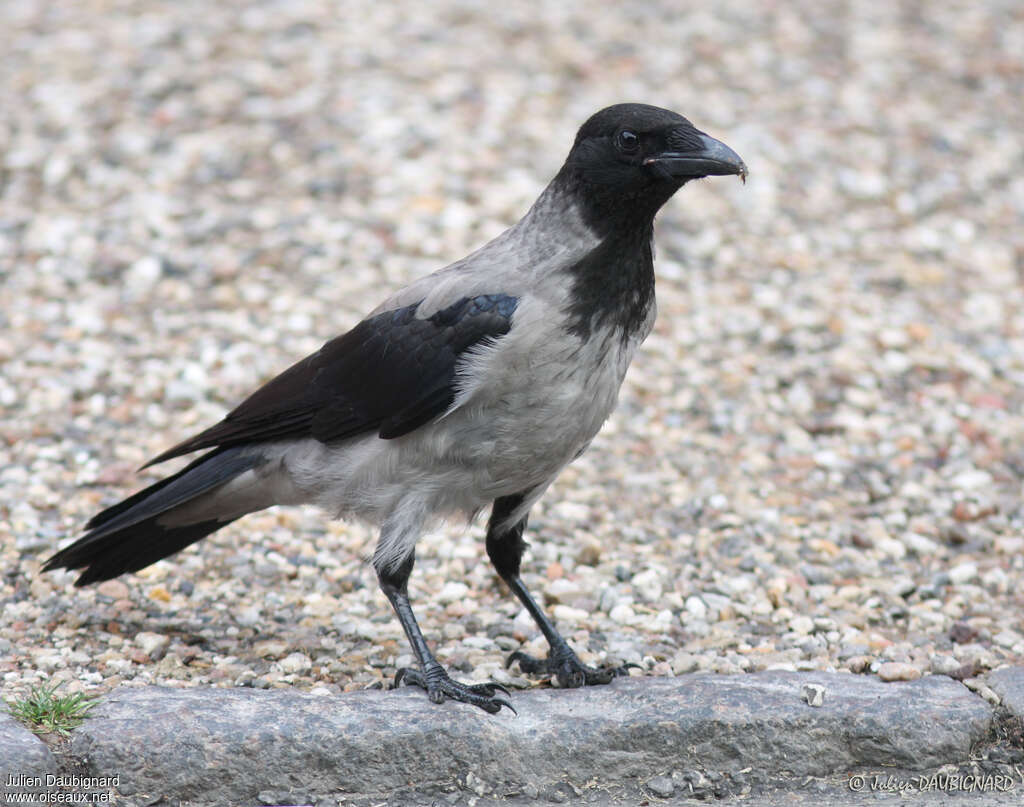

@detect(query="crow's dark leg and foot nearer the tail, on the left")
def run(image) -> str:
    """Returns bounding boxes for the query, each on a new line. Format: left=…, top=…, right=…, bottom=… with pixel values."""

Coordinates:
left=377, top=553, right=515, bottom=714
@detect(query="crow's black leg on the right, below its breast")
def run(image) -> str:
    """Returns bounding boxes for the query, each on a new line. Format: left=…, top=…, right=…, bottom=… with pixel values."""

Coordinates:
left=487, top=496, right=629, bottom=687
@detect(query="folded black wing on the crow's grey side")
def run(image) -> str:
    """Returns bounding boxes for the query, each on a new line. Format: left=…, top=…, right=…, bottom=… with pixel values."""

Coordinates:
left=148, top=294, right=519, bottom=465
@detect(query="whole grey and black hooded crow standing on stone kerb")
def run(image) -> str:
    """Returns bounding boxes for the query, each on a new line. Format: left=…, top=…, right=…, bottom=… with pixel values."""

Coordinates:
left=44, top=103, right=746, bottom=712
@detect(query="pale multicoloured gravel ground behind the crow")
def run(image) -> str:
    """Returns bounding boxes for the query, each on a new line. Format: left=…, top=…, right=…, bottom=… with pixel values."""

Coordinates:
left=0, top=0, right=1024, bottom=697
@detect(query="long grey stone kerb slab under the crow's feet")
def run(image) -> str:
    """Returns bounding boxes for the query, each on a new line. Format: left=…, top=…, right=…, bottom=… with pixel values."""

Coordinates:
left=72, top=672, right=992, bottom=803
